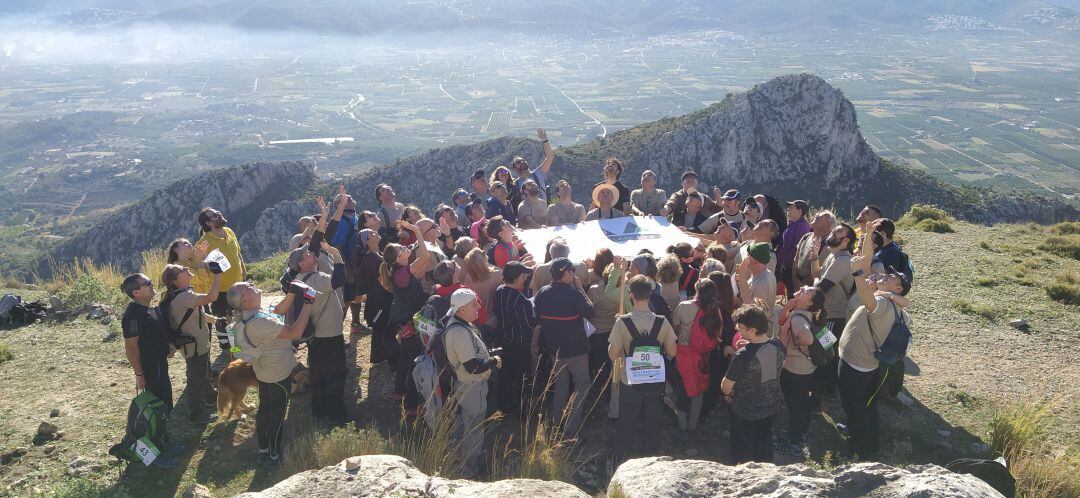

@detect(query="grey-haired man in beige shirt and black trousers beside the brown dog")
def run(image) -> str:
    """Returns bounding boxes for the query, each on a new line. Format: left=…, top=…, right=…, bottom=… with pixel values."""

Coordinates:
left=226, top=282, right=313, bottom=470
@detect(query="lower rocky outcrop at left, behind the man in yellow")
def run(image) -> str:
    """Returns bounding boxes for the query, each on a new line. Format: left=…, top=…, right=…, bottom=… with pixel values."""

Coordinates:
left=44, top=162, right=315, bottom=275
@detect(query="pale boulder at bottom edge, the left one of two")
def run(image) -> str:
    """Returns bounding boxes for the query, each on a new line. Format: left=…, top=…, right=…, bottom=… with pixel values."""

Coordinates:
left=238, top=455, right=589, bottom=498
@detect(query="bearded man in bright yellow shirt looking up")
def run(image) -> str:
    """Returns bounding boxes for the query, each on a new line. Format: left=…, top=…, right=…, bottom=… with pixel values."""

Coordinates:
left=192, top=207, right=247, bottom=352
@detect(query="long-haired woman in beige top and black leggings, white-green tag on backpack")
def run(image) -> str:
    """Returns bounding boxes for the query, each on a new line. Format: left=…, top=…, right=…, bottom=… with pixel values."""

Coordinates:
left=774, top=286, right=825, bottom=456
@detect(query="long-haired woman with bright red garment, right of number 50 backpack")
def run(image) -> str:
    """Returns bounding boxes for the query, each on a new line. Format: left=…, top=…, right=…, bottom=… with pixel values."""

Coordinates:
left=672, top=279, right=724, bottom=431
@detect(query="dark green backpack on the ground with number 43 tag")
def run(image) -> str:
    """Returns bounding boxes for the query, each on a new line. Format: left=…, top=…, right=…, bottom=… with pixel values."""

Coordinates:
left=109, top=389, right=168, bottom=467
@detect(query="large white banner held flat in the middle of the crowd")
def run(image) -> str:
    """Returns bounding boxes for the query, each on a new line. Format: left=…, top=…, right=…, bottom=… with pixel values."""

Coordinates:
left=516, top=216, right=698, bottom=263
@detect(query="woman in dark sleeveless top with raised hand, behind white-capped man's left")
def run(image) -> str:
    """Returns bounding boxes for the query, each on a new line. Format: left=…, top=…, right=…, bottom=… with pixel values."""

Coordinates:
left=379, top=219, right=431, bottom=412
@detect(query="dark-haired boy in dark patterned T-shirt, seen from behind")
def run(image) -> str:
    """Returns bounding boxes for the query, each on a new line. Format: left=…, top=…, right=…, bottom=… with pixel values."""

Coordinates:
left=720, top=305, right=787, bottom=466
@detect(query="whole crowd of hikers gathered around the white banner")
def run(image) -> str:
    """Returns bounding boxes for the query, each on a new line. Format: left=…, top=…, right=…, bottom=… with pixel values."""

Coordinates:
left=116, top=130, right=913, bottom=475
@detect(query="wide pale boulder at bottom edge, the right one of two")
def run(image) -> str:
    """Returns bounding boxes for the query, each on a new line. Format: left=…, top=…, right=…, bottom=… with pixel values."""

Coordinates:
left=608, top=457, right=1001, bottom=498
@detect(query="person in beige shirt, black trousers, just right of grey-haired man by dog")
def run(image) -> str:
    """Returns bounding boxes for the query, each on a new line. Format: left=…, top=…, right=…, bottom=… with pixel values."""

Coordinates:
left=282, top=234, right=348, bottom=426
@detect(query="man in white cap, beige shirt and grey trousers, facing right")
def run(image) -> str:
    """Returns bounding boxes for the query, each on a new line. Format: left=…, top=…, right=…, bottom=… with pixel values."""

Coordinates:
left=443, top=288, right=502, bottom=477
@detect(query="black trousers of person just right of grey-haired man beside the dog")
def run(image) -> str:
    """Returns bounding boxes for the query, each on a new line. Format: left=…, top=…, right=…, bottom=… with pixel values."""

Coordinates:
left=308, top=336, right=347, bottom=423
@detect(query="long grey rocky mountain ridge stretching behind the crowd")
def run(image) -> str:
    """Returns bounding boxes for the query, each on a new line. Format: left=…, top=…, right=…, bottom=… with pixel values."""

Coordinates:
left=38, top=73, right=1080, bottom=268
